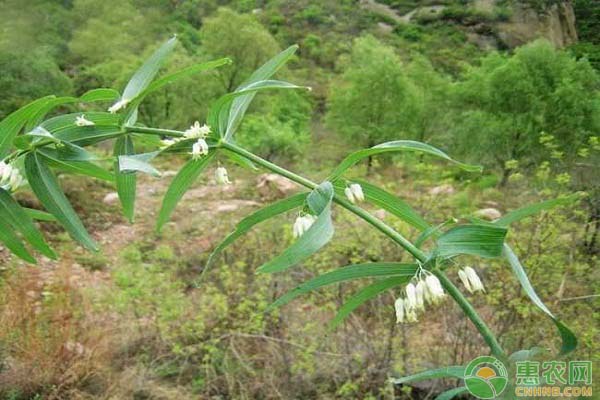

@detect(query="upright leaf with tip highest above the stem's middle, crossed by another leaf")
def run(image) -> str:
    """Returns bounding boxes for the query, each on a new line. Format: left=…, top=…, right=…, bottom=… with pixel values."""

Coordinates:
left=225, top=45, right=298, bottom=140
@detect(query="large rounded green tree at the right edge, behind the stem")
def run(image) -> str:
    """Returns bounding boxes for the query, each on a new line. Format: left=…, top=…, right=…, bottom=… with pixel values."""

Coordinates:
left=451, top=41, right=600, bottom=182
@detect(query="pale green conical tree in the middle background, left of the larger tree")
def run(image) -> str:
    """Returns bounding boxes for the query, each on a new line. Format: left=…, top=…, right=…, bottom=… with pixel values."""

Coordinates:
left=326, top=36, right=423, bottom=152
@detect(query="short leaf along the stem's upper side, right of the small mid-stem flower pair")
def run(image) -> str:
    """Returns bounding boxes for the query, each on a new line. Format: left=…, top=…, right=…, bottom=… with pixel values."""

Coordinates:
left=353, top=180, right=430, bottom=230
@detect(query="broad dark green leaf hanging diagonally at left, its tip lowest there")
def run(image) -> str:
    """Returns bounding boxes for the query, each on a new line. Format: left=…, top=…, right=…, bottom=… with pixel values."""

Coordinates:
left=25, top=152, right=98, bottom=250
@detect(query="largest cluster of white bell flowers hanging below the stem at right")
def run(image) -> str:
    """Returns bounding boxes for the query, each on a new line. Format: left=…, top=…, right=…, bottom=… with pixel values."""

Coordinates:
left=394, top=269, right=446, bottom=324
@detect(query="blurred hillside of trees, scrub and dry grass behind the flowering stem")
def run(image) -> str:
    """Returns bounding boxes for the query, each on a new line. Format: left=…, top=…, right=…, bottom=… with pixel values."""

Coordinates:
left=0, top=0, right=600, bottom=400
